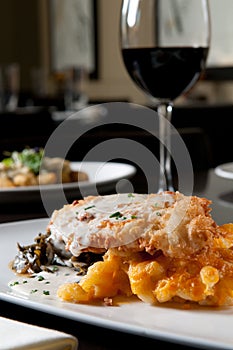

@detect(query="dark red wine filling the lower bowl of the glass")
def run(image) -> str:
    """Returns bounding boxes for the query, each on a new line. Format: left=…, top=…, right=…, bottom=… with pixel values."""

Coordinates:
left=122, top=47, right=208, bottom=100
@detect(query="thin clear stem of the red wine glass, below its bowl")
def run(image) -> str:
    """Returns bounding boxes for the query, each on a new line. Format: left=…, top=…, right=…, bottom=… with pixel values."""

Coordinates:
left=157, top=102, right=174, bottom=192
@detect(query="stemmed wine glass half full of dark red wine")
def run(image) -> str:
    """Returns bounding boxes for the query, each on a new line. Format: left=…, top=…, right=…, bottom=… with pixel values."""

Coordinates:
left=120, top=0, right=210, bottom=192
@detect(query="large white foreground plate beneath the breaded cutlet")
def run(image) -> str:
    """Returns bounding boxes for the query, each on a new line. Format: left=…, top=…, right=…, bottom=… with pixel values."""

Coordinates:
left=0, top=219, right=233, bottom=350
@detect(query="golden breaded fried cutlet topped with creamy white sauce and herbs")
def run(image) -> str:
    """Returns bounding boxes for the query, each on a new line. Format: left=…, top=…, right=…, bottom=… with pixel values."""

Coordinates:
left=47, top=192, right=218, bottom=257
